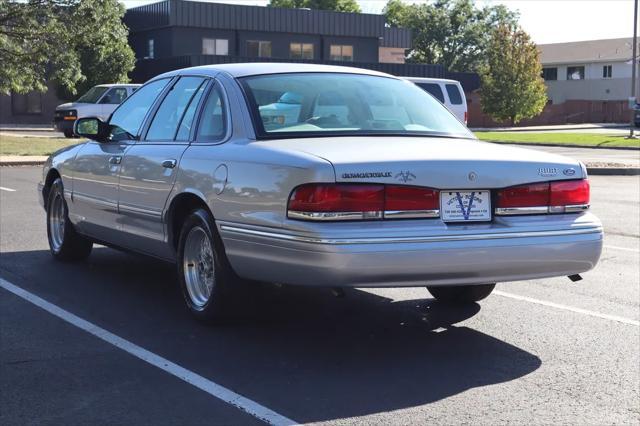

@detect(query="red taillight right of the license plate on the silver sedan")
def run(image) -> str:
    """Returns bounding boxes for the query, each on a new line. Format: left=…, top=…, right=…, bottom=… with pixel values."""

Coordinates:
left=496, top=179, right=589, bottom=215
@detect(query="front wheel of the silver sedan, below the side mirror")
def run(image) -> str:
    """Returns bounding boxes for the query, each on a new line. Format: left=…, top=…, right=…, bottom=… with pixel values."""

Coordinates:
left=47, top=178, right=93, bottom=261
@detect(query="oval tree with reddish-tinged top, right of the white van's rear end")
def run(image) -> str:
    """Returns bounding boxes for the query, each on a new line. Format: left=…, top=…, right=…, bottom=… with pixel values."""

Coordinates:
left=480, top=26, right=547, bottom=125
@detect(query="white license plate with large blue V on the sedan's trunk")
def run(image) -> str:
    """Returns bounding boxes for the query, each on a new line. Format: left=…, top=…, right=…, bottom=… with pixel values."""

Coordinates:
left=440, top=189, right=491, bottom=222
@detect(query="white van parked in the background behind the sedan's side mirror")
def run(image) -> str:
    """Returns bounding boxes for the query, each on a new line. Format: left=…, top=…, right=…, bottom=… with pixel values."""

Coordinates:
left=53, top=84, right=140, bottom=138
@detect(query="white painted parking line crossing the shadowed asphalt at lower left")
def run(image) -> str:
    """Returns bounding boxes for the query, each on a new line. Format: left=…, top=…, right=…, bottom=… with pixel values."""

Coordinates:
left=0, top=278, right=297, bottom=425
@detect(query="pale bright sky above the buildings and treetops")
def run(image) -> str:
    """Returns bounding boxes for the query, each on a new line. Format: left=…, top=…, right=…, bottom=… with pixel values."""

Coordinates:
left=123, top=0, right=640, bottom=44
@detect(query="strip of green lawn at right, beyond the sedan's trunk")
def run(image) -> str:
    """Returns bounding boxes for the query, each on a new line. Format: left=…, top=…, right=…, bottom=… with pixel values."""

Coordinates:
left=475, top=132, right=640, bottom=148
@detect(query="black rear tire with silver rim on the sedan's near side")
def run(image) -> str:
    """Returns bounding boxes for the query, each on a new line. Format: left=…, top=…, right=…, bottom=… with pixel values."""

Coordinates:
left=177, top=208, right=246, bottom=323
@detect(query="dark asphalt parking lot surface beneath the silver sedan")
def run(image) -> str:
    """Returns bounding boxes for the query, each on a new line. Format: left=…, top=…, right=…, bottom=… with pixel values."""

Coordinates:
left=0, top=167, right=640, bottom=425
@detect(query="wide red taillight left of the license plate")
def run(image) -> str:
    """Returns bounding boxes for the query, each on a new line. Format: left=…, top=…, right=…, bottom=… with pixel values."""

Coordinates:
left=288, top=183, right=440, bottom=220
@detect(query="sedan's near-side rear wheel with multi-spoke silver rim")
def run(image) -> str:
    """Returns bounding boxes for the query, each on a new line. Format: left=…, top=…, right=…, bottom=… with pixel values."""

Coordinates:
left=177, top=209, right=241, bottom=322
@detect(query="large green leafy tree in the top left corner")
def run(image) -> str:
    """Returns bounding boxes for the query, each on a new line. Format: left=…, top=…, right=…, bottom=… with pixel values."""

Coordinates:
left=0, top=0, right=135, bottom=97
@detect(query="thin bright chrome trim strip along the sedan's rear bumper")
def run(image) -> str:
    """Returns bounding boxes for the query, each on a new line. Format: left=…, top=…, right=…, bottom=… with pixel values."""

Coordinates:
left=220, top=225, right=603, bottom=245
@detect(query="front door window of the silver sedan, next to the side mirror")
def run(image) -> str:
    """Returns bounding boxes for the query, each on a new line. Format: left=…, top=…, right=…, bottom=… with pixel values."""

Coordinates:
left=109, top=78, right=170, bottom=140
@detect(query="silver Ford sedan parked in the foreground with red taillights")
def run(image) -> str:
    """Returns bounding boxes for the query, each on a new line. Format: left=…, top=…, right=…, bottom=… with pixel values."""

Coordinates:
left=38, top=63, right=603, bottom=319
